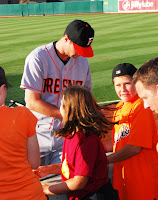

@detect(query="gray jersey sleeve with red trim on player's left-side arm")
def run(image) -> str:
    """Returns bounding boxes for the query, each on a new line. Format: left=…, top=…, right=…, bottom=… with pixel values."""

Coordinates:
left=20, top=53, right=43, bottom=93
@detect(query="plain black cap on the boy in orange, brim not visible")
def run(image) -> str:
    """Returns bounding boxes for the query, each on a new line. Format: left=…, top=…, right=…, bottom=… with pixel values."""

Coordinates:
left=112, top=63, right=137, bottom=80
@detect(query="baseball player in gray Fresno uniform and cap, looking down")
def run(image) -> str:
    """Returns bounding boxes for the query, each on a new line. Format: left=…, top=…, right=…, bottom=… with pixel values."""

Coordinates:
left=20, top=20, right=94, bottom=165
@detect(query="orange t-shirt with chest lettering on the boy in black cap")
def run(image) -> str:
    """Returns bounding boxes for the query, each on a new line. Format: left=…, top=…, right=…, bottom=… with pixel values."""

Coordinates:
left=113, top=96, right=158, bottom=200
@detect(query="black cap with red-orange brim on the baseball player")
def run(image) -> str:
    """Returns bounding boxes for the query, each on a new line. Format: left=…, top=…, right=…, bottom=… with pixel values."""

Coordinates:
left=65, top=20, right=94, bottom=57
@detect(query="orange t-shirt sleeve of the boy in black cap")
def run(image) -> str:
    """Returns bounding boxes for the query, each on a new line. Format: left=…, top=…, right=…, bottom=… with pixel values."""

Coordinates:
left=128, top=105, right=155, bottom=148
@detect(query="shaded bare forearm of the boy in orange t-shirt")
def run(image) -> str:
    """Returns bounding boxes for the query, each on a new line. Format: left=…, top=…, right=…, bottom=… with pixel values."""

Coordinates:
left=107, top=144, right=142, bottom=163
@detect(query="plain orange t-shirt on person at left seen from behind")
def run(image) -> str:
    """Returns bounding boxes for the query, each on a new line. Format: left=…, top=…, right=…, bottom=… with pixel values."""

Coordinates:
left=0, top=106, right=47, bottom=200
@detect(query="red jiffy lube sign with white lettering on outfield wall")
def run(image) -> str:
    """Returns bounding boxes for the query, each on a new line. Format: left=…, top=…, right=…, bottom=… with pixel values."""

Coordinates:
left=118, top=0, right=158, bottom=12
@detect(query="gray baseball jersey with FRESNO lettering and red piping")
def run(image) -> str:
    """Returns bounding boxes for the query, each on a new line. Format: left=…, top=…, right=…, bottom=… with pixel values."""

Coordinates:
left=20, top=43, right=92, bottom=152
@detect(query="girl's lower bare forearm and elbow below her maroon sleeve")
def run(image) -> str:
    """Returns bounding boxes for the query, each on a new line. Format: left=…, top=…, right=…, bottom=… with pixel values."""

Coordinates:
left=42, top=176, right=89, bottom=195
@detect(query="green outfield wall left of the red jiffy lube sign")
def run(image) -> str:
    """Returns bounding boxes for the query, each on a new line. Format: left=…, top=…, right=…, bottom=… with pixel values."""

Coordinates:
left=0, top=0, right=118, bottom=16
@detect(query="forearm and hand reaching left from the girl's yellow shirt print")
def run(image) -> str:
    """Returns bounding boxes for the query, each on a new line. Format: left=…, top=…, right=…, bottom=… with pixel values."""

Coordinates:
left=34, top=163, right=61, bottom=178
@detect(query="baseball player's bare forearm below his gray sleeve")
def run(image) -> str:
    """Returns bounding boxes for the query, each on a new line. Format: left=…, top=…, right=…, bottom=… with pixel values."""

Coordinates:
left=25, top=89, right=62, bottom=119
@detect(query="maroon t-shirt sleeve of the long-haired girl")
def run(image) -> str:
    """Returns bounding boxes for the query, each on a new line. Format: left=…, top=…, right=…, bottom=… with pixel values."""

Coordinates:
left=74, top=137, right=98, bottom=177
